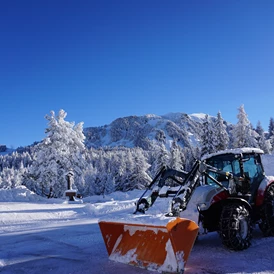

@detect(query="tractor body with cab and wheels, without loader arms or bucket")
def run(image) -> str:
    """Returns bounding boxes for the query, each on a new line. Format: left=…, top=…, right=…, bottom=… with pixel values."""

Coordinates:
left=199, top=148, right=274, bottom=250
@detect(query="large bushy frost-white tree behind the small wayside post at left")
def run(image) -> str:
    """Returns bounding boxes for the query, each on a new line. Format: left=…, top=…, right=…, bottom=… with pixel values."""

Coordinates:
left=26, top=109, right=85, bottom=197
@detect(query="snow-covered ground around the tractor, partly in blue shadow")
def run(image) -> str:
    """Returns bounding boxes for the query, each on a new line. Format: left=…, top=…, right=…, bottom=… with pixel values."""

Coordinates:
left=0, top=184, right=274, bottom=274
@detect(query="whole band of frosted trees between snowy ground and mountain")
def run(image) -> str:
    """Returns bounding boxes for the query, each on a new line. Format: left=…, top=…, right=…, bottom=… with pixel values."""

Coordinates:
left=0, top=105, right=274, bottom=197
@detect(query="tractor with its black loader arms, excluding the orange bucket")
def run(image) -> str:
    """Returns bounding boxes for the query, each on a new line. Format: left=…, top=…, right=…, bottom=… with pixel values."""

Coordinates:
left=136, top=148, right=274, bottom=250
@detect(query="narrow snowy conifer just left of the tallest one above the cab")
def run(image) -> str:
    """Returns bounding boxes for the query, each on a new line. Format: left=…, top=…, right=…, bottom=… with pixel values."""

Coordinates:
left=214, top=111, right=229, bottom=151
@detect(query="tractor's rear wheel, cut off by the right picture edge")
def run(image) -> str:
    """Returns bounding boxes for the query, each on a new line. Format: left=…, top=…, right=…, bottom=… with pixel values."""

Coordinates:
left=259, top=184, right=274, bottom=236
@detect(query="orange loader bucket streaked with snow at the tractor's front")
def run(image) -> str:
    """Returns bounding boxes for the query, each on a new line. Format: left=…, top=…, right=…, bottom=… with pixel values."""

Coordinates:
left=99, top=218, right=198, bottom=273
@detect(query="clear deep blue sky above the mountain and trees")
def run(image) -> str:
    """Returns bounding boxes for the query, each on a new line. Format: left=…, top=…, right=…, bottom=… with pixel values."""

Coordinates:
left=0, top=0, right=274, bottom=148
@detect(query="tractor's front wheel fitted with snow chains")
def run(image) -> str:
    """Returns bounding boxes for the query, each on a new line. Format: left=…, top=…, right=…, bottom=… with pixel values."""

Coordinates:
left=219, top=203, right=252, bottom=250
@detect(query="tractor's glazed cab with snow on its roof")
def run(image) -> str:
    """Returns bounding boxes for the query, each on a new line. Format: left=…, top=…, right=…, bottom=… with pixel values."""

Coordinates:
left=202, top=148, right=265, bottom=199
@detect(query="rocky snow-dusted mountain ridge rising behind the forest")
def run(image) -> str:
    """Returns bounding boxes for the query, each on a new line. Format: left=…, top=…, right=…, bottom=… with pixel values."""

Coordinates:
left=84, top=113, right=223, bottom=149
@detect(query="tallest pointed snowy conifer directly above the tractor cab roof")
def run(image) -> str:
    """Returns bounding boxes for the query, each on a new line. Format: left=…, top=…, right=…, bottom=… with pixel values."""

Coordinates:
left=232, top=105, right=258, bottom=148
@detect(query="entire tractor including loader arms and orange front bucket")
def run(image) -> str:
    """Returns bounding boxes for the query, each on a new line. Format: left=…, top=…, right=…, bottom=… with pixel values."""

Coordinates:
left=99, top=148, right=274, bottom=273
